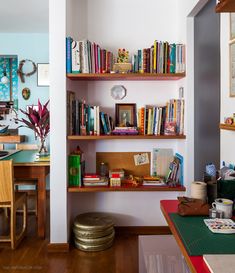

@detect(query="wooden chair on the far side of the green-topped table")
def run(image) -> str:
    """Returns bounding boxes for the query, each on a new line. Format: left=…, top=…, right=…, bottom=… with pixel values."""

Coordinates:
left=14, top=143, right=38, bottom=216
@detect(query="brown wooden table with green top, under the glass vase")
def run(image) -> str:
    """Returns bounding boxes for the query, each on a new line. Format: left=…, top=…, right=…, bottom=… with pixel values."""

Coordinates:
left=4, top=151, right=50, bottom=239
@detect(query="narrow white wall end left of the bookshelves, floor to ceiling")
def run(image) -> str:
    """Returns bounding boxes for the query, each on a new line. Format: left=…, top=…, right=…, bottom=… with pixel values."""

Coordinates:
left=49, top=0, right=68, bottom=243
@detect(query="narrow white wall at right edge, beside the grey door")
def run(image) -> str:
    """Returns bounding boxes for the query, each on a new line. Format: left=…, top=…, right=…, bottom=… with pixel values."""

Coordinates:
left=220, top=13, right=235, bottom=164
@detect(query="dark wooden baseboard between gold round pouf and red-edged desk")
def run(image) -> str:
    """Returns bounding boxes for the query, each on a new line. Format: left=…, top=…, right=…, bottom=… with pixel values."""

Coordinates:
left=115, top=226, right=171, bottom=235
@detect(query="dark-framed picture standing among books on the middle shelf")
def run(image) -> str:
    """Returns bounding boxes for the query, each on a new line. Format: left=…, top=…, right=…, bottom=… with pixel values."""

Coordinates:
left=115, top=103, right=137, bottom=127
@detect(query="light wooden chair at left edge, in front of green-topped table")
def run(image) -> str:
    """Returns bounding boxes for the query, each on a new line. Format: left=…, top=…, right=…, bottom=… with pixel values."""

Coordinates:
left=0, top=160, right=27, bottom=249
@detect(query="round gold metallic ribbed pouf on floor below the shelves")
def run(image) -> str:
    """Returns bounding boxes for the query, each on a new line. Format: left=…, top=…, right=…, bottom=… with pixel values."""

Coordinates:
left=73, top=212, right=115, bottom=251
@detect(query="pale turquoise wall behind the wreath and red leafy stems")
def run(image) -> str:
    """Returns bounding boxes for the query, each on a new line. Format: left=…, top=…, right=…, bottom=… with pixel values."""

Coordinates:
left=0, top=33, right=49, bottom=143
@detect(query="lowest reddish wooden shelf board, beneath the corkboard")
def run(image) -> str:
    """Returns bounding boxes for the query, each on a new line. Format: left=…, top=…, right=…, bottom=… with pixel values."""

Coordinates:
left=68, top=186, right=186, bottom=192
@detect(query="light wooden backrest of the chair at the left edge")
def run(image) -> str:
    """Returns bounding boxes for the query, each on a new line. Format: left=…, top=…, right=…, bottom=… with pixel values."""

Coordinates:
left=0, top=160, right=14, bottom=202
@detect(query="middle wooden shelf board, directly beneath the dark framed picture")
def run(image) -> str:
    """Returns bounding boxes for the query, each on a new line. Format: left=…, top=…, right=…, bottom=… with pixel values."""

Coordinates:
left=68, top=135, right=186, bottom=140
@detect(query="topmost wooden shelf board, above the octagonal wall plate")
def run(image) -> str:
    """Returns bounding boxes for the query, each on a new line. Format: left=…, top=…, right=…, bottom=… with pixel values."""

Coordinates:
left=67, top=73, right=185, bottom=81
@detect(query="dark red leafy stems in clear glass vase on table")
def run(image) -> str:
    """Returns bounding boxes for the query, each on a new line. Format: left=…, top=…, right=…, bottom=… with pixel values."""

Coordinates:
left=16, top=100, right=50, bottom=156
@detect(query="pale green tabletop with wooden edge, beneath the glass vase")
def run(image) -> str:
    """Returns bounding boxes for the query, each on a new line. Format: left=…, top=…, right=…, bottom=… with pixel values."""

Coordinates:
left=3, top=150, right=50, bottom=166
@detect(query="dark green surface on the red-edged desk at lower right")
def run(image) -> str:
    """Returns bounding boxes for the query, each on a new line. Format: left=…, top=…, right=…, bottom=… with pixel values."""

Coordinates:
left=169, top=213, right=235, bottom=256
